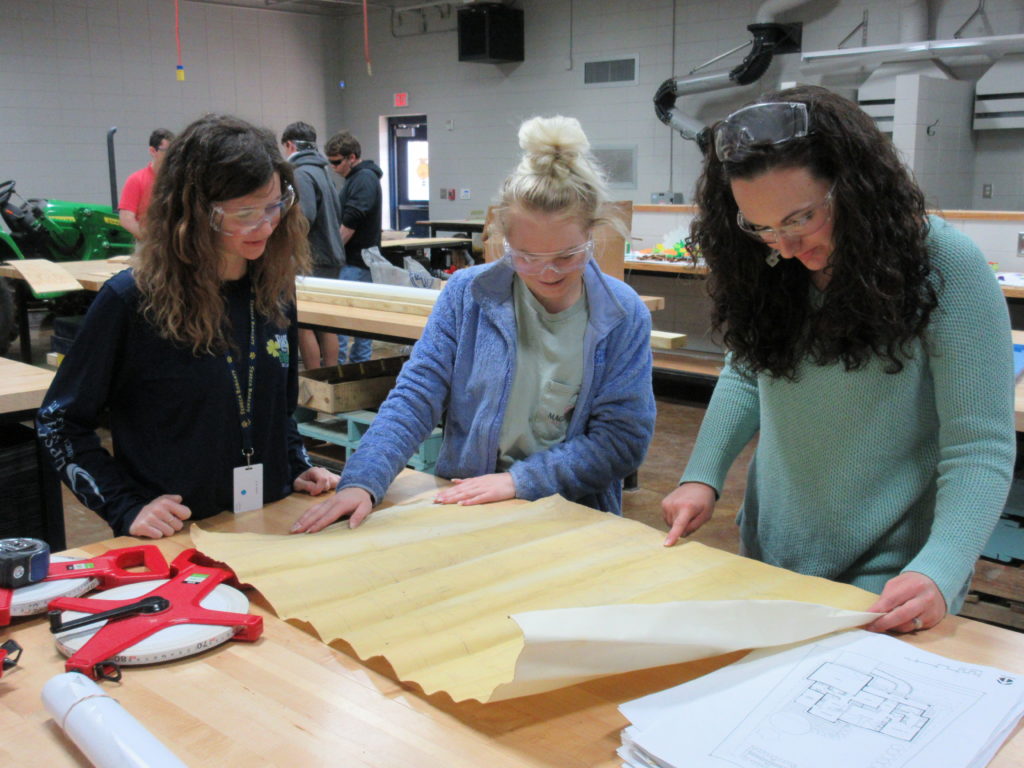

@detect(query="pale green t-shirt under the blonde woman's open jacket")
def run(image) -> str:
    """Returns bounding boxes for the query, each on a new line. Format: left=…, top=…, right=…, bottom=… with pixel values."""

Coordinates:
left=498, top=275, right=588, bottom=471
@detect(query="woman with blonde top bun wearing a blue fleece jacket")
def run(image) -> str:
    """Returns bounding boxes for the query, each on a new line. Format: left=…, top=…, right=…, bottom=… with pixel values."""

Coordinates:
left=292, top=117, right=654, bottom=532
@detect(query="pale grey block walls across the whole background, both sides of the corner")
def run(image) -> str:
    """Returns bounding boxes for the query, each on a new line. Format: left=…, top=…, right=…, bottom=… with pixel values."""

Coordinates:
left=0, top=0, right=1024, bottom=217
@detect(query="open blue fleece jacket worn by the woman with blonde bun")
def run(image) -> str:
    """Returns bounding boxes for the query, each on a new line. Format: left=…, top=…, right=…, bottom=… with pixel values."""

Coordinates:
left=339, top=261, right=654, bottom=514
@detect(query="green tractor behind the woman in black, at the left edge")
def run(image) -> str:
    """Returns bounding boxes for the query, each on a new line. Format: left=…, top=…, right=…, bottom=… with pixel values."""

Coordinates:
left=0, top=180, right=135, bottom=355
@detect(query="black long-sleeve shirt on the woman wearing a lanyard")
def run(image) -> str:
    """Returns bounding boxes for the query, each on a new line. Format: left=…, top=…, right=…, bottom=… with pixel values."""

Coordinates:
left=37, top=270, right=309, bottom=535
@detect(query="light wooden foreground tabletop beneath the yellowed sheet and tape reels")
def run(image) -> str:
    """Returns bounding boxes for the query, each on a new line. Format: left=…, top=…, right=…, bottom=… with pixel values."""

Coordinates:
left=0, top=470, right=1024, bottom=768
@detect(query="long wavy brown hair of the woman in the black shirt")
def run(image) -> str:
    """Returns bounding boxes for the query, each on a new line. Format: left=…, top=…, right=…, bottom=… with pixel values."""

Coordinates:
left=135, top=115, right=309, bottom=354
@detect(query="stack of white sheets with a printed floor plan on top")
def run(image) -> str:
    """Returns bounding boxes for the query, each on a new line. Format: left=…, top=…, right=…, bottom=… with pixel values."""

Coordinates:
left=618, top=630, right=1024, bottom=768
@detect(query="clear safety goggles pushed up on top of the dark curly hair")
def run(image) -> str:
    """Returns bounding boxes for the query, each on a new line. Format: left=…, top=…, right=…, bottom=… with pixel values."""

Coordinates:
left=714, top=101, right=810, bottom=163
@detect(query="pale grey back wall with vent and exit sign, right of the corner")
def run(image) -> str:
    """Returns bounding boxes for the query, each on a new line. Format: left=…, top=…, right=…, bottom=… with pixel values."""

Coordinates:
left=328, top=0, right=1024, bottom=224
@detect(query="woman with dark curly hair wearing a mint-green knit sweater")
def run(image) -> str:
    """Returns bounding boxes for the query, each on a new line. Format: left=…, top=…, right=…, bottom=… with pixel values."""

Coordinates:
left=662, top=86, right=1015, bottom=632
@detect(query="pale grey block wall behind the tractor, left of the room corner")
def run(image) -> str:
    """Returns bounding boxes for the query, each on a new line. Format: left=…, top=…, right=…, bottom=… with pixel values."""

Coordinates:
left=0, top=0, right=328, bottom=204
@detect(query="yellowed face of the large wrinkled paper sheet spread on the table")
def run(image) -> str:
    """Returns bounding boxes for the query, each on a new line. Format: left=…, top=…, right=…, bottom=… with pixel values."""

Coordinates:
left=191, top=497, right=877, bottom=701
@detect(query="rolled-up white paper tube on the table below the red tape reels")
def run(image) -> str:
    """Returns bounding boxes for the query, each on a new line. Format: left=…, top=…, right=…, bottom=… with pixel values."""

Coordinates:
left=43, top=672, right=186, bottom=768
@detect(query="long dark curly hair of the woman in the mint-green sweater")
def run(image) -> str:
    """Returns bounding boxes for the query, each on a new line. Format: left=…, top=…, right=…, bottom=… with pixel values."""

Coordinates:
left=690, top=86, right=938, bottom=380
